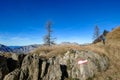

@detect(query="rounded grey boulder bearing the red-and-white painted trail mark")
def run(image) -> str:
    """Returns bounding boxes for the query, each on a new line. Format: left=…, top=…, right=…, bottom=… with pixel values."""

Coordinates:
left=44, top=51, right=109, bottom=80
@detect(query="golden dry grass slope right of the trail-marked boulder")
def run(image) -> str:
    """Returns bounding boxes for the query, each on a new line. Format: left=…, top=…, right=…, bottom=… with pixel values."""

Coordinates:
left=91, top=44, right=120, bottom=80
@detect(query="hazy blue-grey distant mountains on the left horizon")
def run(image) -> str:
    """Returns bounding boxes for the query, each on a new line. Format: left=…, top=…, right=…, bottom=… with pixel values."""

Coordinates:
left=0, top=44, right=40, bottom=53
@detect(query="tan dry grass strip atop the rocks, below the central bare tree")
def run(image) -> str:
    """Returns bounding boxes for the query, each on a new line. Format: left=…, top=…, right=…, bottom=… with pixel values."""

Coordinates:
left=31, top=44, right=84, bottom=58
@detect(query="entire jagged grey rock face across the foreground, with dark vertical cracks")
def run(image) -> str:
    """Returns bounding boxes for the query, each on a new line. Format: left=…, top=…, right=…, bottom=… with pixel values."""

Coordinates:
left=4, top=50, right=109, bottom=80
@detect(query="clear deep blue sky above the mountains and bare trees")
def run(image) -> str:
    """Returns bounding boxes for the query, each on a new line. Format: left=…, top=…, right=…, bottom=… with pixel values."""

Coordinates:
left=0, top=0, right=120, bottom=45
